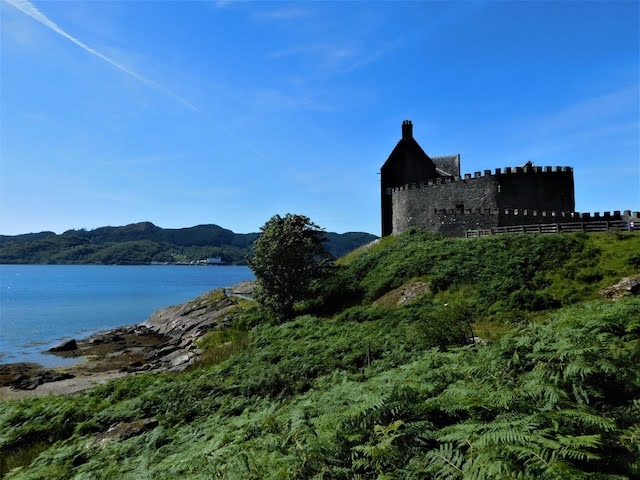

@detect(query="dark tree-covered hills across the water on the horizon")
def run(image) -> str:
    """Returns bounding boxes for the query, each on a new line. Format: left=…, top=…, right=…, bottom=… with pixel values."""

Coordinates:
left=0, top=222, right=377, bottom=265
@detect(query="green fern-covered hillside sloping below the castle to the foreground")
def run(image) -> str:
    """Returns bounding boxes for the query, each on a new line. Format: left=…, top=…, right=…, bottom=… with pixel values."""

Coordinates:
left=0, top=231, right=640, bottom=479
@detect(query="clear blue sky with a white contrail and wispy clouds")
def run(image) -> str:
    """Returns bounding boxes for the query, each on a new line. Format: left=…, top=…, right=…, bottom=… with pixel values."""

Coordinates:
left=0, top=0, right=640, bottom=234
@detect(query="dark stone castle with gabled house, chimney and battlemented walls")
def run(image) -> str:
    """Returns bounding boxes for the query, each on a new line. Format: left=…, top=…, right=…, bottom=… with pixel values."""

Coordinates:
left=380, top=120, right=638, bottom=236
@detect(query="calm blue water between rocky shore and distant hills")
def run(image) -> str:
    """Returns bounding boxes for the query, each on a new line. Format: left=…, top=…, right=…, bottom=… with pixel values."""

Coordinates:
left=0, top=265, right=253, bottom=367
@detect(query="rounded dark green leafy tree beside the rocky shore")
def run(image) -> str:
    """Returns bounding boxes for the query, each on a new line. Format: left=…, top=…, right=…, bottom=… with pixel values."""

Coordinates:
left=248, top=213, right=330, bottom=319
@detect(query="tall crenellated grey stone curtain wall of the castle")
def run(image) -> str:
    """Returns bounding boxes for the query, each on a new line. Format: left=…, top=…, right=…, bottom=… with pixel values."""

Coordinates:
left=387, top=167, right=575, bottom=235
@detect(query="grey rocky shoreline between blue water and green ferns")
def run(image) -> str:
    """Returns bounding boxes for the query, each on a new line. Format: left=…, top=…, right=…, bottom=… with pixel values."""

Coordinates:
left=0, top=281, right=254, bottom=401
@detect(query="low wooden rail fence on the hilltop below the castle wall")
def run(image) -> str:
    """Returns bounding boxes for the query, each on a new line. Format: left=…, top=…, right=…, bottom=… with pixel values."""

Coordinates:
left=466, top=220, right=640, bottom=238
